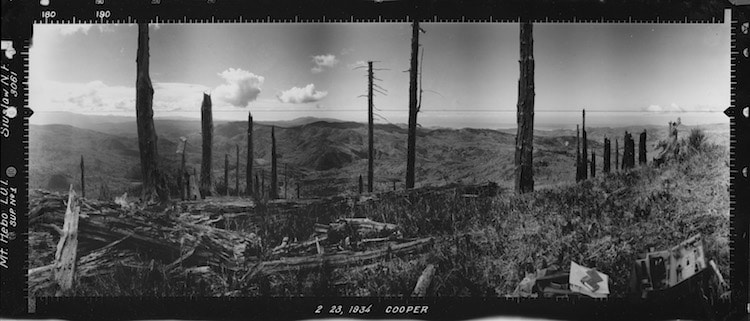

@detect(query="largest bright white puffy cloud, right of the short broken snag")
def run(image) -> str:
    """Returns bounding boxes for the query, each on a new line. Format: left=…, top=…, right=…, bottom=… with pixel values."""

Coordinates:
left=214, top=68, right=264, bottom=107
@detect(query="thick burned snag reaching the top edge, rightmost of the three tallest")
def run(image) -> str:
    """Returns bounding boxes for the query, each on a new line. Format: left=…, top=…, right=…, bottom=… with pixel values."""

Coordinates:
left=515, top=22, right=534, bottom=193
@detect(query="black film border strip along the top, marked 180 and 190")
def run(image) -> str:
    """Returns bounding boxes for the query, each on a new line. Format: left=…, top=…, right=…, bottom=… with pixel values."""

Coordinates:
left=3, top=0, right=739, bottom=38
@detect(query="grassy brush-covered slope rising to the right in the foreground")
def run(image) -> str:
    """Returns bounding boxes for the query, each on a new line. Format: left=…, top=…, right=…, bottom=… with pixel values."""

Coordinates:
left=330, top=139, right=729, bottom=296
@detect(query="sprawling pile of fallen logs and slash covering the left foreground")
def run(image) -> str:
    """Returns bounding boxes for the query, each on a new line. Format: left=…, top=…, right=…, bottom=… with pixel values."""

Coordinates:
left=29, top=190, right=433, bottom=293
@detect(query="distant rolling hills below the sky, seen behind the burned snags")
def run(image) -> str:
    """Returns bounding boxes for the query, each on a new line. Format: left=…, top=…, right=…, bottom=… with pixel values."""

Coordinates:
left=29, top=118, right=728, bottom=197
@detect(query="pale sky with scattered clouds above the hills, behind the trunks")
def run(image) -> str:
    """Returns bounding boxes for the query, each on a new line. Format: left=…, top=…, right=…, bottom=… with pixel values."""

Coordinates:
left=29, top=14, right=730, bottom=128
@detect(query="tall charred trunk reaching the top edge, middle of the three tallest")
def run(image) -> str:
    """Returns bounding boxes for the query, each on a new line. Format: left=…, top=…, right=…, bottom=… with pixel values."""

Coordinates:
left=406, top=17, right=419, bottom=189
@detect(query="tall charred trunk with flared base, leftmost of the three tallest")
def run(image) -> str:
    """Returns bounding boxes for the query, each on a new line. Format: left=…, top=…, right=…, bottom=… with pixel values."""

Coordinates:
left=135, top=23, right=169, bottom=202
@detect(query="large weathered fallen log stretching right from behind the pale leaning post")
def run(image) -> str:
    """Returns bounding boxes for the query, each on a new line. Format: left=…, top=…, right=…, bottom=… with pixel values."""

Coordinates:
left=29, top=189, right=261, bottom=269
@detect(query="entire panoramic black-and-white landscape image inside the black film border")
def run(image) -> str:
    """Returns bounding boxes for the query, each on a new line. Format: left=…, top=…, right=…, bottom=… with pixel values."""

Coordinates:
left=28, top=15, right=730, bottom=309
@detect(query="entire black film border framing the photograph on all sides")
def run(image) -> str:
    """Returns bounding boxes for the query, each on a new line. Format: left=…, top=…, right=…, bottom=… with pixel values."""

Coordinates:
left=0, top=0, right=750, bottom=318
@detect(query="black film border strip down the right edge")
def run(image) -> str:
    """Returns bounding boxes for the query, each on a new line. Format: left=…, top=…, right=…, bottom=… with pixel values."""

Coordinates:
left=726, top=6, right=750, bottom=313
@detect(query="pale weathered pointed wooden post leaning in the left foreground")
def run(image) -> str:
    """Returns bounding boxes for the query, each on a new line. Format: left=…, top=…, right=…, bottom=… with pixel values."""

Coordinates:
left=54, top=185, right=81, bottom=296
